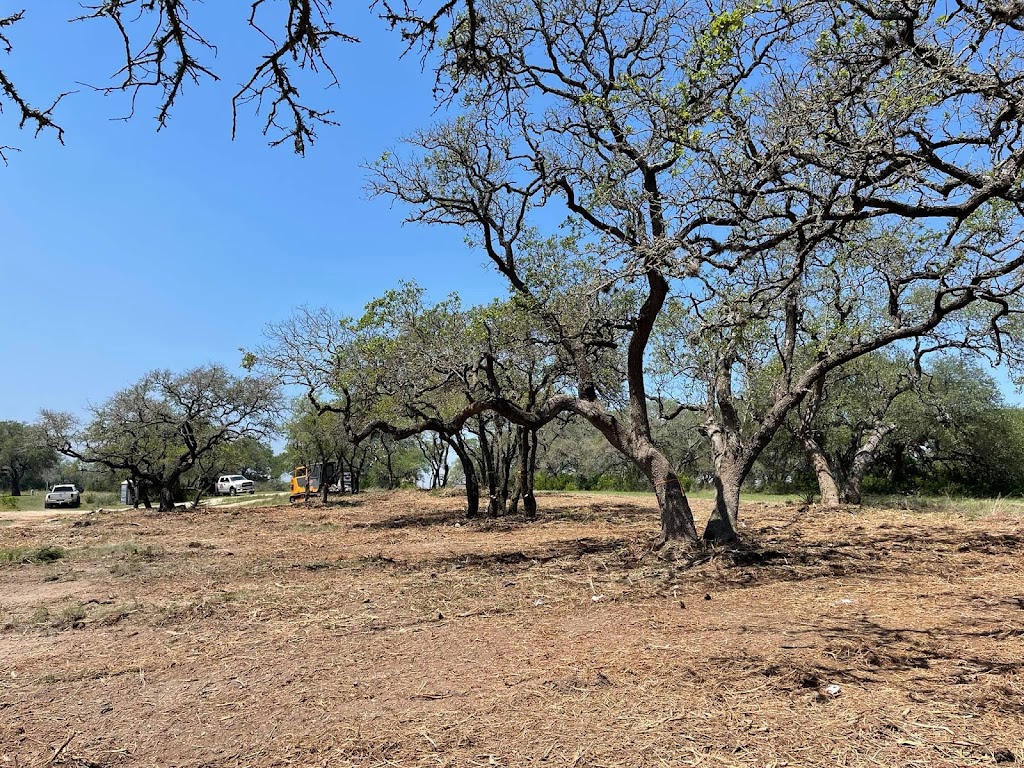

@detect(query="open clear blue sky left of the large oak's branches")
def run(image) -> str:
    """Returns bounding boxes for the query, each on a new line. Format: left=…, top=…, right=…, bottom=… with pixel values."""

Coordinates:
left=0, top=0, right=502, bottom=421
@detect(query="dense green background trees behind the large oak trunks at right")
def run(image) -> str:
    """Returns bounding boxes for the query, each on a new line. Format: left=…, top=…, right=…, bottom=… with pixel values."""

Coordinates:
left=537, top=355, right=1024, bottom=505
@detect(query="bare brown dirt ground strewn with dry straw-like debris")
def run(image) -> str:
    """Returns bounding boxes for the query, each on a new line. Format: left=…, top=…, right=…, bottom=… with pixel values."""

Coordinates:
left=0, top=493, right=1024, bottom=768
